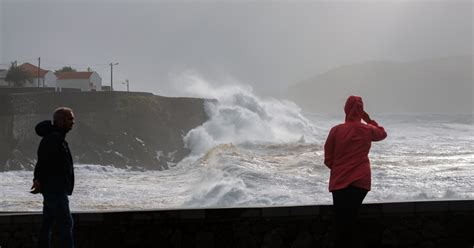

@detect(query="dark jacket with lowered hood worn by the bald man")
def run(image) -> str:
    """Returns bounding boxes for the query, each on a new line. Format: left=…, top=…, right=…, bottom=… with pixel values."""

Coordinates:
left=34, top=121, right=74, bottom=195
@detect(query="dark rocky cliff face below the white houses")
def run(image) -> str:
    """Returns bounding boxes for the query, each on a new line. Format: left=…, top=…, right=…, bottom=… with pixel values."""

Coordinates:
left=0, top=92, right=207, bottom=170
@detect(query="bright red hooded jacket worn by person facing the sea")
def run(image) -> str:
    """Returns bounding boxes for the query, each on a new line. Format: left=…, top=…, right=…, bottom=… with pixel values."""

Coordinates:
left=324, top=96, right=387, bottom=192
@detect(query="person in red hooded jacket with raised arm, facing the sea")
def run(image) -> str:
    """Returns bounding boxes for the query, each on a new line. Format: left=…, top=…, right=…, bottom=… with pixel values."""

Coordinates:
left=324, top=96, right=387, bottom=247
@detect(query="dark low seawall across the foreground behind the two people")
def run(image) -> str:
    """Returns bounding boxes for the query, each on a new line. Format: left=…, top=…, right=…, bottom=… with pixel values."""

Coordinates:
left=0, top=201, right=474, bottom=248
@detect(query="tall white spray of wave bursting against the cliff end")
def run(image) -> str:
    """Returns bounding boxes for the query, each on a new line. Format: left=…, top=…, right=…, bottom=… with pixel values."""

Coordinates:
left=174, top=73, right=316, bottom=156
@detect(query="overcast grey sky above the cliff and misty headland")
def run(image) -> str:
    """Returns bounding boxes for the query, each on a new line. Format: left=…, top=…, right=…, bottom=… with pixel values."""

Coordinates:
left=0, top=0, right=473, bottom=95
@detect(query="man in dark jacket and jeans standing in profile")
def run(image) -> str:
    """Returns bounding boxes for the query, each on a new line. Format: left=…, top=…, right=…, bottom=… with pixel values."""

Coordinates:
left=31, top=107, right=74, bottom=248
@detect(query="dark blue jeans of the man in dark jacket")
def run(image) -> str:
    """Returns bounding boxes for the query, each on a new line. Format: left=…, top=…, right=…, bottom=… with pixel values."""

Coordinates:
left=39, top=193, right=74, bottom=248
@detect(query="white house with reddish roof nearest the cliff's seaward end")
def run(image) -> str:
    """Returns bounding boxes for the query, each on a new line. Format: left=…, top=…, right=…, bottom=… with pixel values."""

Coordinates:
left=56, top=71, right=102, bottom=91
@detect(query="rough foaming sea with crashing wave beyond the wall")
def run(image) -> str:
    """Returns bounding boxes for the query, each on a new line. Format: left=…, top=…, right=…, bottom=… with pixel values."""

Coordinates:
left=0, top=77, right=474, bottom=211
